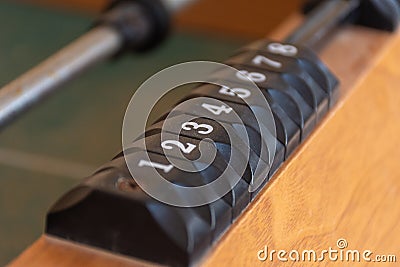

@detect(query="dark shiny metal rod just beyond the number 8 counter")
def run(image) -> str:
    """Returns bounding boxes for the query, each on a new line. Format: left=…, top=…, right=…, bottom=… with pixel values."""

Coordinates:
left=286, top=0, right=360, bottom=48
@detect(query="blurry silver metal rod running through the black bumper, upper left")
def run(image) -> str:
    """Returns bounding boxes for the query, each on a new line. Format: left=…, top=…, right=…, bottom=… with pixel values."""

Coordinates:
left=0, top=0, right=195, bottom=129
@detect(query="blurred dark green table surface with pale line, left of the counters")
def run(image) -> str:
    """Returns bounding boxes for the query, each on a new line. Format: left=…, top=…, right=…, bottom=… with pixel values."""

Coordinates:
left=0, top=2, right=243, bottom=266
